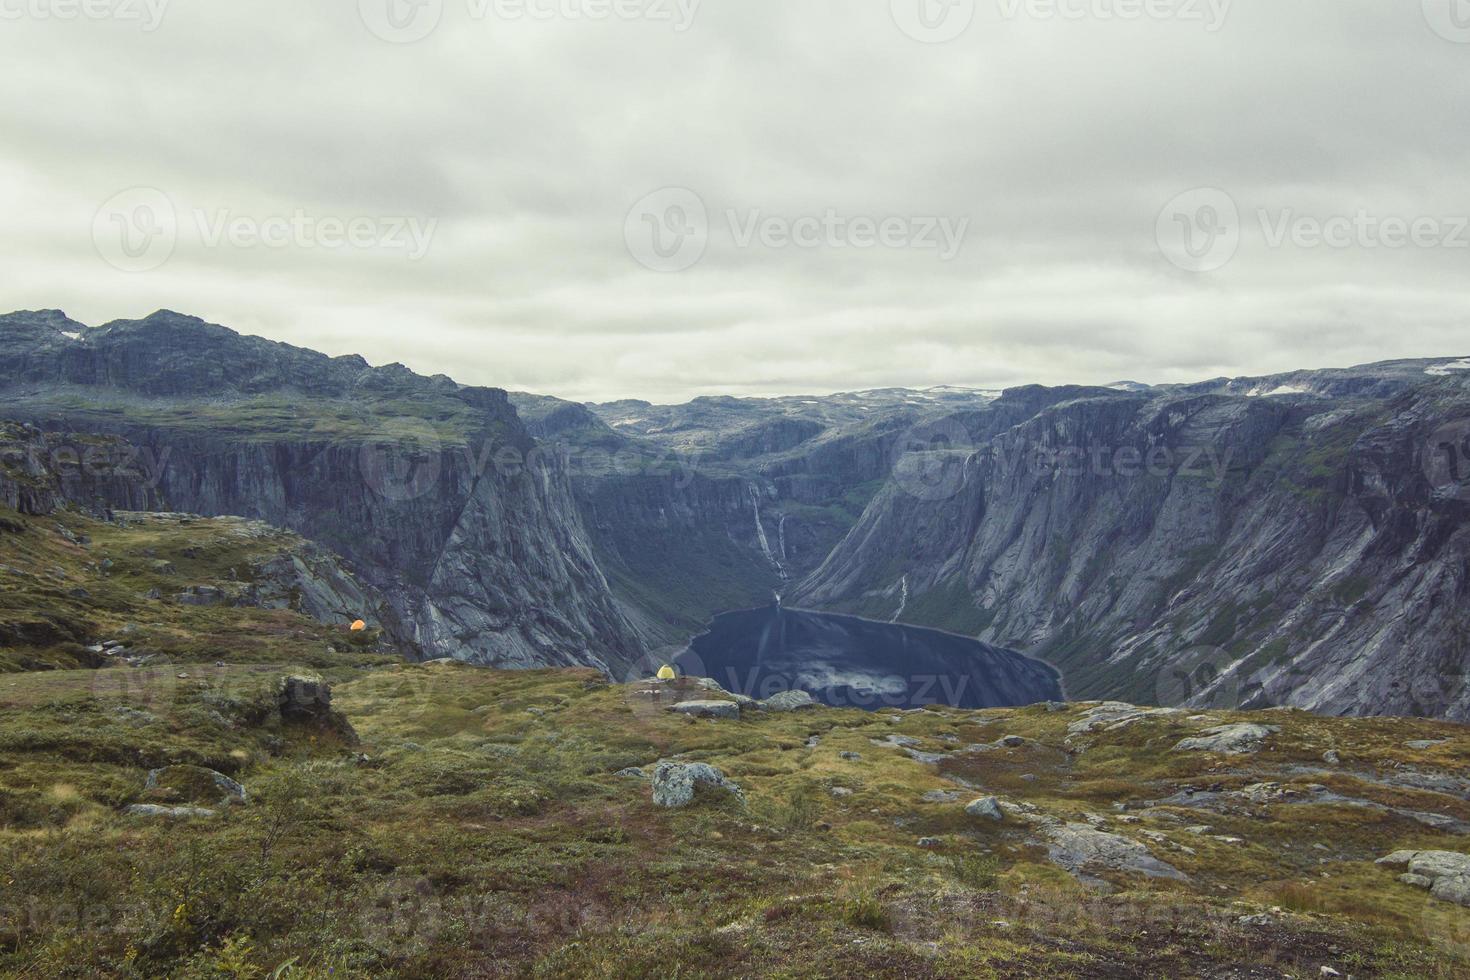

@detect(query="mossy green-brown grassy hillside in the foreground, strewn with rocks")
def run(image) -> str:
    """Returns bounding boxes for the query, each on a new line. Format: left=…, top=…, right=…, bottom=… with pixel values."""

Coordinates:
left=0, top=502, right=1470, bottom=980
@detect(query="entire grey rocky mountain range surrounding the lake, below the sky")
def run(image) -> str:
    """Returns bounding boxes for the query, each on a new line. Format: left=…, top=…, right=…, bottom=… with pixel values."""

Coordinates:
left=0, top=311, right=1470, bottom=721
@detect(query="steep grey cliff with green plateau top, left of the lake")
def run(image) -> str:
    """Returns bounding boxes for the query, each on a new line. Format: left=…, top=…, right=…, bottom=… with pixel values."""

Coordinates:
left=0, top=313, right=639, bottom=671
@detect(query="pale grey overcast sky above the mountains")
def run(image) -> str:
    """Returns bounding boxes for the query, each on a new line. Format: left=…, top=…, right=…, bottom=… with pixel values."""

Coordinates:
left=0, top=0, right=1470, bottom=401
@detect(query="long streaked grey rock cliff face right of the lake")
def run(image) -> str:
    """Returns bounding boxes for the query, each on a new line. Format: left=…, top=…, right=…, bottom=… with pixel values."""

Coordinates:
left=795, top=376, right=1470, bottom=718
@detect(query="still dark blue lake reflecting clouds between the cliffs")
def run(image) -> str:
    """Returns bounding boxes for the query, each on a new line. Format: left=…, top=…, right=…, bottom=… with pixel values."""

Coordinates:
left=676, top=605, right=1061, bottom=710
